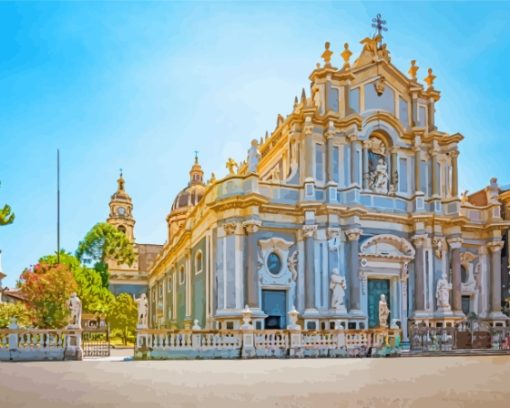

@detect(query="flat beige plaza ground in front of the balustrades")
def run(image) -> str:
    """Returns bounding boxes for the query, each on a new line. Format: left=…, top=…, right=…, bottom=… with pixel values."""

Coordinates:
left=0, top=351, right=510, bottom=408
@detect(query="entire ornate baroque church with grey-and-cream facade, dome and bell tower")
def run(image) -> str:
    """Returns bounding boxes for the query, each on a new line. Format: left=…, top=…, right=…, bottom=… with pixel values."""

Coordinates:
left=104, top=27, right=510, bottom=340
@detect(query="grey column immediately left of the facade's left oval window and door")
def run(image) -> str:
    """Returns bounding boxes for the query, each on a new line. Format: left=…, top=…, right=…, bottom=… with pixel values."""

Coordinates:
left=243, top=220, right=261, bottom=308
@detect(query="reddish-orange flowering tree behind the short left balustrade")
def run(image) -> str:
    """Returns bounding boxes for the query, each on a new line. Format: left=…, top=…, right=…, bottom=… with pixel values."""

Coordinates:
left=18, top=262, right=76, bottom=329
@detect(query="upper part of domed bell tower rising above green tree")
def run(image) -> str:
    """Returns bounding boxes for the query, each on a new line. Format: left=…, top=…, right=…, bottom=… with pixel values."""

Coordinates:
left=106, top=169, right=136, bottom=242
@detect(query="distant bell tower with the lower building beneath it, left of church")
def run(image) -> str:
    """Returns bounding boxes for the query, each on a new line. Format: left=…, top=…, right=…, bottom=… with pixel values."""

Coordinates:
left=106, top=173, right=163, bottom=296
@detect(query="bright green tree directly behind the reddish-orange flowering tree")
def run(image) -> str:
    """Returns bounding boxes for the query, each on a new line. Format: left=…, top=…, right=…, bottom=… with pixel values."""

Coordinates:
left=39, top=251, right=114, bottom=316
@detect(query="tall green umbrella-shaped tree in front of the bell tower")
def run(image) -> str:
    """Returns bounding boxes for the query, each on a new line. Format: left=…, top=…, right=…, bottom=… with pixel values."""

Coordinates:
left=76, top=222, right=135, bottom=288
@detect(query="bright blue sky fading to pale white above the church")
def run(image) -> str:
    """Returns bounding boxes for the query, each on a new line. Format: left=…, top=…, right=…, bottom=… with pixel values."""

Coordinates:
left=0, top=2, right=510, bottom=286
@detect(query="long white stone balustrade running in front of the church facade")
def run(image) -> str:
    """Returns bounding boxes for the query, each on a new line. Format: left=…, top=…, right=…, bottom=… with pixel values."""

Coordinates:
left=135, top=326, right=401, bottom=359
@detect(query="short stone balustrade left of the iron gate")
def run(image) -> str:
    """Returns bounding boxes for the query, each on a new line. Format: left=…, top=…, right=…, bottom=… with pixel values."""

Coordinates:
left=0, top=322, right=82, bottom=361
